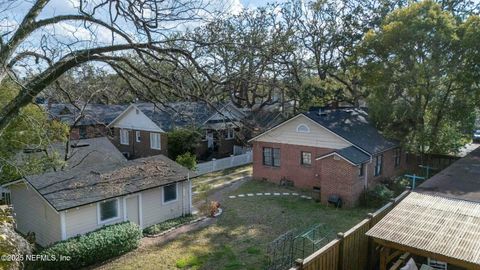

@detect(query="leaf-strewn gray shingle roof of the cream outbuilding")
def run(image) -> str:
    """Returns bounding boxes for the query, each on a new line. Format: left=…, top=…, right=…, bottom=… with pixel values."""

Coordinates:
left=25, top=155, right=193, bottom=211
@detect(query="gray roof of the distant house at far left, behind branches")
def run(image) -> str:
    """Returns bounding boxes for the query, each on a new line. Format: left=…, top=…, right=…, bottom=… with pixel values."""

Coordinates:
left=43, top=103, right=128, bottom=125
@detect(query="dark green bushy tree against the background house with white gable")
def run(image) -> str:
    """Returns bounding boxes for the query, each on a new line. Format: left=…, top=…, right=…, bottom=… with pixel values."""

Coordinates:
left=167, top=128, right=200, bottom=160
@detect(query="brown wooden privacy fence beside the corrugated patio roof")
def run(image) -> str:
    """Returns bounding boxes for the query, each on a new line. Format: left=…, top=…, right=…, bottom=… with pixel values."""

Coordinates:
left=290, top=190, right=410, bottom=270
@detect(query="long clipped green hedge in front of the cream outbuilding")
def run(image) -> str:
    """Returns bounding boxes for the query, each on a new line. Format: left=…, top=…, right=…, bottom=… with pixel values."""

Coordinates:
left=34, top=222, right=142, bottom=269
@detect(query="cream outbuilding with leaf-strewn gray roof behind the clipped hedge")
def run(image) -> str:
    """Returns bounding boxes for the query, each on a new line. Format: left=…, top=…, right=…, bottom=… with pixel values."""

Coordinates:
left=5, top=141, right=193, bottom=246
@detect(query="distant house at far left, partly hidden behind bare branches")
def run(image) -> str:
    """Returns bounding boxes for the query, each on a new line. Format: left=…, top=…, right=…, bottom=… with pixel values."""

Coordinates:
left=44, top=103, right=127, bottom=140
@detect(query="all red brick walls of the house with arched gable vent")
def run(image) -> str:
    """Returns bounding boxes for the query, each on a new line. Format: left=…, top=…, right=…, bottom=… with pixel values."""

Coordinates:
left=253, top=142, right=406, bottom=207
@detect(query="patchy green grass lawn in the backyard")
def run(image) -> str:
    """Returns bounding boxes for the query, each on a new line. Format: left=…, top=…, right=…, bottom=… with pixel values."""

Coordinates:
left=94, top=181, right=370, bottom=269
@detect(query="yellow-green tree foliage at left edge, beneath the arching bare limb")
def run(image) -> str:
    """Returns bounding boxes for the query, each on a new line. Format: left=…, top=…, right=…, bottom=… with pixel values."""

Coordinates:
left=0, top=80, right=68, bottom=183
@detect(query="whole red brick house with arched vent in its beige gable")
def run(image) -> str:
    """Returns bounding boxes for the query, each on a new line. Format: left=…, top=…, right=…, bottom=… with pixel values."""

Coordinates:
left=251, top=108, right=405, bottom=206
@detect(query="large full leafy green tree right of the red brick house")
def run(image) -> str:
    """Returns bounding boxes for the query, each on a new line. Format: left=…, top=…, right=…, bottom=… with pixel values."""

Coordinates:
left=362, top=1, right=479, bottom=154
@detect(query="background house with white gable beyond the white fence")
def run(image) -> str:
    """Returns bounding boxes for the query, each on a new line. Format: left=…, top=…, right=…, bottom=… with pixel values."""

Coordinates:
left=109, top=102, right=245, bottom=159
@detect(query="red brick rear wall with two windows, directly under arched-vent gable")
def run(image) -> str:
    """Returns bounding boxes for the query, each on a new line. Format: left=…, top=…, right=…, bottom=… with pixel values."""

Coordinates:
left=253, top=142, right=332, bottom=189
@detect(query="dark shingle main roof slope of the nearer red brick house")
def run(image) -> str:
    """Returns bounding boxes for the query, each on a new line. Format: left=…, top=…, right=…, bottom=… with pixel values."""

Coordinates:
left=303, top=108, right=398, bottom=154
